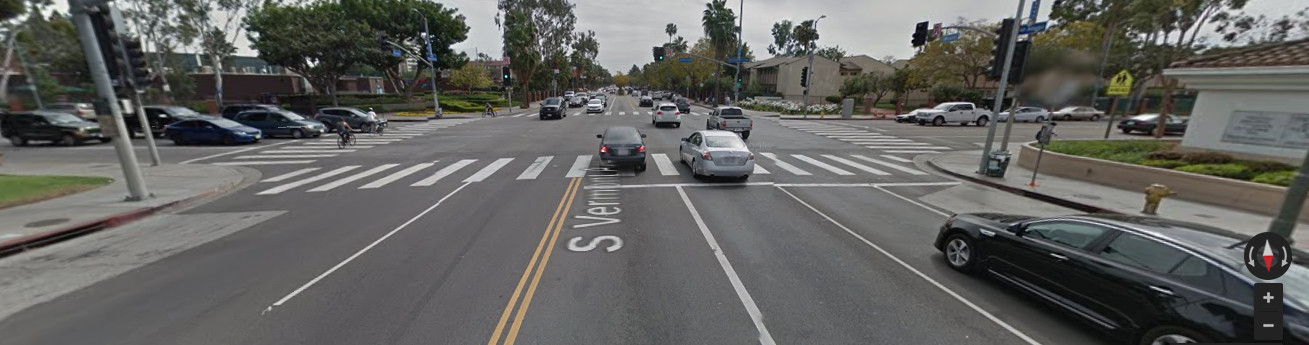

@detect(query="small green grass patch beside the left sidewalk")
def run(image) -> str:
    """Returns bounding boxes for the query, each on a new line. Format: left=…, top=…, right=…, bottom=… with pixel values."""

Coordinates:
left=0, top=175, right=114, bottom=209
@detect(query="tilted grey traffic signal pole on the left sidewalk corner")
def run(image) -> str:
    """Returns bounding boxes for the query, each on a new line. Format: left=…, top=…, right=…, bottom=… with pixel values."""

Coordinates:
left=68, top=0, right=149, bottom=201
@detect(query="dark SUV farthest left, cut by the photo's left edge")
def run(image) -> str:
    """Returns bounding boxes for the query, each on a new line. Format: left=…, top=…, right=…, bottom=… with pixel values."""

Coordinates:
left=0, top=110, right=110, bottom=146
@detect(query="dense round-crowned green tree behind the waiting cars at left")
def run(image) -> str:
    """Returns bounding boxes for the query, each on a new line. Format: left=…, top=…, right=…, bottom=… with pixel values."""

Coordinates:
left=245, top=3, right=376, bottom=105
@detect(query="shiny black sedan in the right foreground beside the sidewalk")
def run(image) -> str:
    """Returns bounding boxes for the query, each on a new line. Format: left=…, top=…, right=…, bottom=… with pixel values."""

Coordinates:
left=935, top=213, right=1309, bottom=345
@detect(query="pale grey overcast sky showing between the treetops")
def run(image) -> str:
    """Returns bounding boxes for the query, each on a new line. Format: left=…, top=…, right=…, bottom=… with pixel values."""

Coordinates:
left=55, top=0, right=1277, bottom=73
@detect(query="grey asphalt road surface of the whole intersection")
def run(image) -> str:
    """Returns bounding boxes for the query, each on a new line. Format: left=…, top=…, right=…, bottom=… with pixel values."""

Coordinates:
left=0, top=92, right=1107, bottom=345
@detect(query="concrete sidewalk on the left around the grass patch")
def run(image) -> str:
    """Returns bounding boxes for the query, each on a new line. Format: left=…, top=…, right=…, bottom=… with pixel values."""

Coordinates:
left=0, top=162, right=259, bottom=256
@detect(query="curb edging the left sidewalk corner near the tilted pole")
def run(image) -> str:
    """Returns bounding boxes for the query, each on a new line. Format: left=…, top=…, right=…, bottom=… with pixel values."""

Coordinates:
left=0, top=167, right=260, bottom=257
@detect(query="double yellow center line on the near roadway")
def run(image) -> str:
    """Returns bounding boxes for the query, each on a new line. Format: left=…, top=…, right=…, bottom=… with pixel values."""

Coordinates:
left=487, top=178, right=581, bottom=345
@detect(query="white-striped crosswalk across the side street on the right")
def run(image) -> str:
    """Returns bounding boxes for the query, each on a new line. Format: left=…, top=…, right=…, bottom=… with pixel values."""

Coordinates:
left=778, top=120, right=950, bottom=154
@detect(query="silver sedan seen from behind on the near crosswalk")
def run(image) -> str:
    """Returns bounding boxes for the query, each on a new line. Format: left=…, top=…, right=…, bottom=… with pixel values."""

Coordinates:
left=678, top=131, right=754, bottom=179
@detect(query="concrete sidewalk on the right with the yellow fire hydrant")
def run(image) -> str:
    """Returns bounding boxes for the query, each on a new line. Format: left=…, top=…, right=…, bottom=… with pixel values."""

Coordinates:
left=927, top=150, right=1309, bottom=250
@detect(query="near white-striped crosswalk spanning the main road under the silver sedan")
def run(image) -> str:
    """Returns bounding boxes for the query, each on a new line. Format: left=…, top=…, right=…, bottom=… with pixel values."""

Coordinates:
left=257, top=152, right=928, bottom=195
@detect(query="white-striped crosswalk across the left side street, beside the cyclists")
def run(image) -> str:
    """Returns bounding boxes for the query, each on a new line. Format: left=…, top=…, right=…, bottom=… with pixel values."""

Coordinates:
left=212, top=119, right=478, bottom=166
